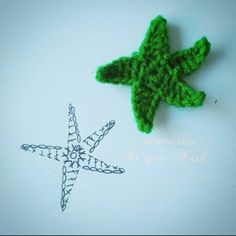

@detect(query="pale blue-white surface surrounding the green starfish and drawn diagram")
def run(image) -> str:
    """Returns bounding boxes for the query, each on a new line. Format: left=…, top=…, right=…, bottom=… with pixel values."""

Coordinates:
left=0, top=0, right=236, bottom=234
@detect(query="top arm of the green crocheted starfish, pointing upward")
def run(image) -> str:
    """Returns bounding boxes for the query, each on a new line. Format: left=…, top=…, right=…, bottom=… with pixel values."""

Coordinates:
left=139, top=16, right=169, bottom=60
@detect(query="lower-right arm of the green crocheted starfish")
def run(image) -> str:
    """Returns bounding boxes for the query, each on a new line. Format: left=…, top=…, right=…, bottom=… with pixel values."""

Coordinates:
left=161, top=81, right=206, bottom=107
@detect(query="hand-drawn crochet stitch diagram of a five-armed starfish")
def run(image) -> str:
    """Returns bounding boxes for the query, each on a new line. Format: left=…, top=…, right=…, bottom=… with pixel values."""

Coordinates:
left=21, top=104, right=125, bottom=211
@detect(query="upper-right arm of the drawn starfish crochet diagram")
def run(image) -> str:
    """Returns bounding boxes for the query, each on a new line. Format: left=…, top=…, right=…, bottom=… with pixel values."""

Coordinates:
left=83, top=120, right=116, bottom=153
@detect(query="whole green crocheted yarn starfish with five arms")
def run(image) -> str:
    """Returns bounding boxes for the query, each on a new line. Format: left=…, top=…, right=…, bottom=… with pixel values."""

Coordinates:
left=96, top=16, right=210, bottom=133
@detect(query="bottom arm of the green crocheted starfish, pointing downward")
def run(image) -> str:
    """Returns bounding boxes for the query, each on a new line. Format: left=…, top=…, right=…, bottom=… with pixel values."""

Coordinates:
left=131, top=81, right=160, bottom=133
